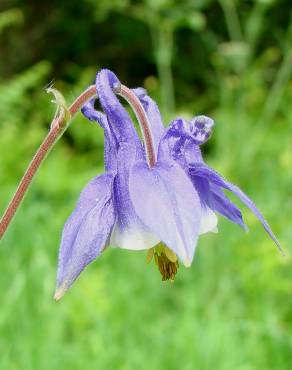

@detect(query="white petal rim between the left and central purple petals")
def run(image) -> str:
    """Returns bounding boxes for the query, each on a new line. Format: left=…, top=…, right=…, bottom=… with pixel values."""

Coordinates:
left=110, top=224, right=160, bottom=251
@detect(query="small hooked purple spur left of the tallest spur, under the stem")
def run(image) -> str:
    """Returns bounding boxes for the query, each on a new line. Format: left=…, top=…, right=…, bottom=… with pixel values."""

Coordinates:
left=81, top=98, right=118, bottom=171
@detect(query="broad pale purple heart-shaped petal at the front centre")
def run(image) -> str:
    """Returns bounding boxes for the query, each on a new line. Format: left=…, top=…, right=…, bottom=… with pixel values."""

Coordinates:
left=130, top=162, right=201, bottom=265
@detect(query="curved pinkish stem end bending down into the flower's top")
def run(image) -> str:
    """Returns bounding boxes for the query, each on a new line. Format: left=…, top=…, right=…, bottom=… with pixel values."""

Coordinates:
left=116, top=85, right=156, bottom=167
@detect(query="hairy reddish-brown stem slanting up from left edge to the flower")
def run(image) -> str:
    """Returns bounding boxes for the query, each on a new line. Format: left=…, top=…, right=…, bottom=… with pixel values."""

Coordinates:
left=0, top=85, right=96, bottom=240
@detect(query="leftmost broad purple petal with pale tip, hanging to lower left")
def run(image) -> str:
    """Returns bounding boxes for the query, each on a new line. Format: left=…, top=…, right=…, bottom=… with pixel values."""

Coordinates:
left=55, top=174, right=115, bottom=299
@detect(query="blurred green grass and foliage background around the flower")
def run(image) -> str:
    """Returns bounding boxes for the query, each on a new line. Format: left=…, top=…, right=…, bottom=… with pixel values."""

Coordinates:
left=0, top=0, right=292, bottom=370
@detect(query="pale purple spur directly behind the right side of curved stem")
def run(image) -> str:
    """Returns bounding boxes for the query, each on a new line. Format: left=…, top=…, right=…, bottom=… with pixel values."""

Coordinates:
left=132, top=88, right=165, bottom=154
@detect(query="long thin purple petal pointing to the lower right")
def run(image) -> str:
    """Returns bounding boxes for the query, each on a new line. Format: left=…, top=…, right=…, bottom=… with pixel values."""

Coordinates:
left=189, top=164, right=283, bottom=253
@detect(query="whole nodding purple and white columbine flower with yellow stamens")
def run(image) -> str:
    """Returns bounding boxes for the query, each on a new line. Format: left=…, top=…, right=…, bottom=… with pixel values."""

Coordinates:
left=55, top=70, right=279, bottom=299
